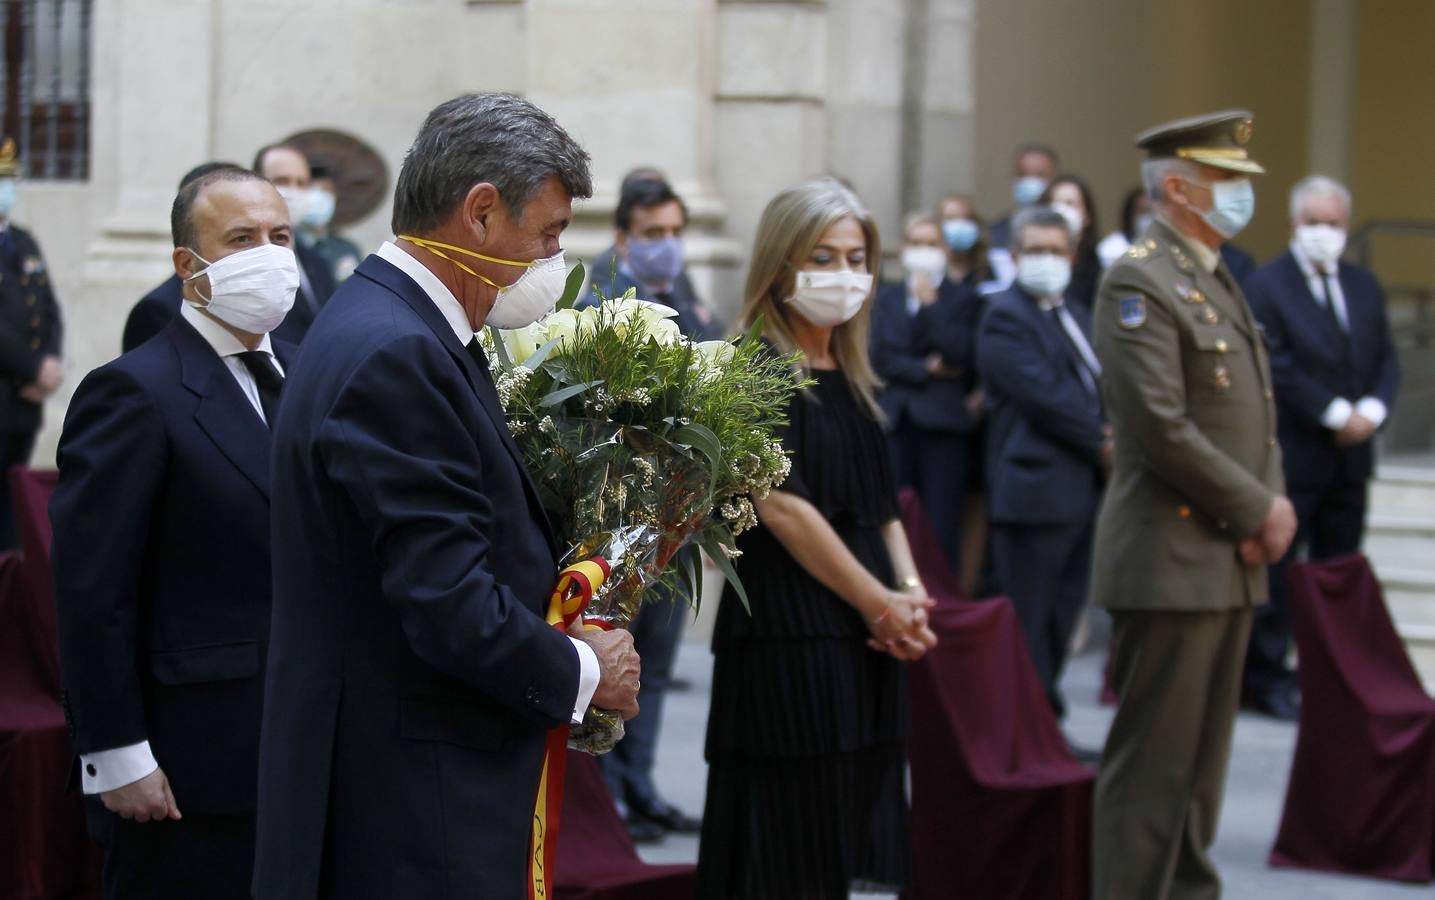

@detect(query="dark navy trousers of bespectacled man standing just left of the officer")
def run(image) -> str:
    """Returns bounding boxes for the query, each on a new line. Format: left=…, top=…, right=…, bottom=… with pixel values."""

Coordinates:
left=992, top=521, right=1092, bottom=716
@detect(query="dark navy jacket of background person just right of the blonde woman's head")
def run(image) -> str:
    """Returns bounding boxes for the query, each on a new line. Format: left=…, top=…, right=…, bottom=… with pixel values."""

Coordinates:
left=870, top=280, right=982, bottom=433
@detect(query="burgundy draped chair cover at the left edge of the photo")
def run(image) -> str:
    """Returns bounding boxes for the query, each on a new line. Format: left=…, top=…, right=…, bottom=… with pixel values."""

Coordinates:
left=0, top=469, right=100, bottom=900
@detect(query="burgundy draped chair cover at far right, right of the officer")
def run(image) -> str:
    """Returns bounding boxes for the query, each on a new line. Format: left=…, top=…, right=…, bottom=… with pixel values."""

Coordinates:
left=1270, top=554, right=1435, bottom=881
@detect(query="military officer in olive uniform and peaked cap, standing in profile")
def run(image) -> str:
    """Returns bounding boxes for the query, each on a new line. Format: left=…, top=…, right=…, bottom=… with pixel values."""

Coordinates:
left=1092, top=111, right=1296, bottom=900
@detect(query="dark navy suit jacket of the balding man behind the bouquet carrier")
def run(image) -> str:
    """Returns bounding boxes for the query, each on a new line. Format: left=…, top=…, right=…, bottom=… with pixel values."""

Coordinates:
left=50, top=319, right=294, bottom=814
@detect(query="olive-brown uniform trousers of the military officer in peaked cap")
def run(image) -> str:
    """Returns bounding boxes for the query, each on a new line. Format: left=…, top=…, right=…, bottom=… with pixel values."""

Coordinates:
left=1092, top=607, right=1253, bottom=900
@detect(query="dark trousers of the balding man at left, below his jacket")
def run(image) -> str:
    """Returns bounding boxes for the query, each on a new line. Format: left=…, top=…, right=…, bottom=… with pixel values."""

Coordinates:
left=86, top=798, right=254, bottom=900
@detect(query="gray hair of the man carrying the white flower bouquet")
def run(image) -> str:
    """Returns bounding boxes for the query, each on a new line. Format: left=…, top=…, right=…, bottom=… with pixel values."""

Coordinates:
left=393, top=92, right=593, bottom=234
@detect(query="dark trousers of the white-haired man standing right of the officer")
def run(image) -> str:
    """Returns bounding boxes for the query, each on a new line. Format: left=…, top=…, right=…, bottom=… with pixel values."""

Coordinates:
left=1243, top=478, right=1369, bottom=698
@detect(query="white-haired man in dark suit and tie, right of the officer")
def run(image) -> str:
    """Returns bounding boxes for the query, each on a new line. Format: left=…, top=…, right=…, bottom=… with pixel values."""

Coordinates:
left=1243, top=175, right=1401, bottom=719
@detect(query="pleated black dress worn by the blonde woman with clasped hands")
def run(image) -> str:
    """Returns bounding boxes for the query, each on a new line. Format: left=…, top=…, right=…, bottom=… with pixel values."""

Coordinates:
left=697, top=370, right=910, bottom=900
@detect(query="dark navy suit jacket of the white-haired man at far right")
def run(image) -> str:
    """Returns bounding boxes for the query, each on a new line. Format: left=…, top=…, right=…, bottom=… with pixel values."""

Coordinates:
left=1243, top=250, right=1401, bottom=487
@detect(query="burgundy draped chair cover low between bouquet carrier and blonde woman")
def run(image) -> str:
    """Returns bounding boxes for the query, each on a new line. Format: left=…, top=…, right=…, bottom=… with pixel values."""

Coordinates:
left=554, top=751, right=697, bottom=900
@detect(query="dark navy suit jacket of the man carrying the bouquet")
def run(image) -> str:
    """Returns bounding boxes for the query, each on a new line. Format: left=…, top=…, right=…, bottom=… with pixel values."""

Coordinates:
left=254, top=249, right=580, bottom=900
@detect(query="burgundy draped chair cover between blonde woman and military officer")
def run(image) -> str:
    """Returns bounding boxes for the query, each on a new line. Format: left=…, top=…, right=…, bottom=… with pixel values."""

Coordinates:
left=903, top=492, right=1095, bottom=900
